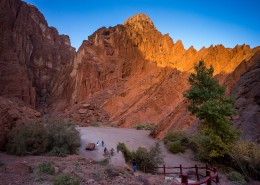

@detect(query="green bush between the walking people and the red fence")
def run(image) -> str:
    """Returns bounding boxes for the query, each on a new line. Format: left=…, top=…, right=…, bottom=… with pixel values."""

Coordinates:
left=117, top=143, right=164, bottom=172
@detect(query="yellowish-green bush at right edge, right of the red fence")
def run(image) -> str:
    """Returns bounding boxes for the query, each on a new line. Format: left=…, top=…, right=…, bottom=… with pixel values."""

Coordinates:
left=229, top=141, right=260, bottom=180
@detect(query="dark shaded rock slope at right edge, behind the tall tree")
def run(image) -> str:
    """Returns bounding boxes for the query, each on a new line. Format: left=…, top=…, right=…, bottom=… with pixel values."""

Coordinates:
left=226, top=51, right=260, bottom=143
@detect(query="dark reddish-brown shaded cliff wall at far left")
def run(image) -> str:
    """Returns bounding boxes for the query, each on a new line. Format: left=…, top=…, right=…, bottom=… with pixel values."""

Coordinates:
left=0, top=0, right=75, bottom=107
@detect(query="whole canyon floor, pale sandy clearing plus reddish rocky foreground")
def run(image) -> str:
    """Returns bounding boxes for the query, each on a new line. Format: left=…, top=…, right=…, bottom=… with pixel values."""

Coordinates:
left=0, top=127, right=238, bottom=185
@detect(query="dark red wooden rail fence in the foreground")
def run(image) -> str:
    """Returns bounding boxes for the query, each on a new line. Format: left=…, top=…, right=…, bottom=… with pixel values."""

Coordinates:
left=146, top=165, right=220, bottom=185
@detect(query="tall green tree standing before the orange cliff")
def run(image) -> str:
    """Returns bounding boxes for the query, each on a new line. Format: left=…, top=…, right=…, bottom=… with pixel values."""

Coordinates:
left=184, top=61, right=239, bottom=160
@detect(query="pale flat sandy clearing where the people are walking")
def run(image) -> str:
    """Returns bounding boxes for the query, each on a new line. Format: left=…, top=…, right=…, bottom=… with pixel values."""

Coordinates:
left=78, top=127, right=199, bottom=166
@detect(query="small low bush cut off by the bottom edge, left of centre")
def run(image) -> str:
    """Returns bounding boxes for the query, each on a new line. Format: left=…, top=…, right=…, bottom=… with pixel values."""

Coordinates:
left=53, top=173, right=80, bottom=185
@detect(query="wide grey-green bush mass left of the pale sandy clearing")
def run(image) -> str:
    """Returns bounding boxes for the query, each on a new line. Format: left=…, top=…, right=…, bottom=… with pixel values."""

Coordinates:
left=7, top=120, right=80, bottom=156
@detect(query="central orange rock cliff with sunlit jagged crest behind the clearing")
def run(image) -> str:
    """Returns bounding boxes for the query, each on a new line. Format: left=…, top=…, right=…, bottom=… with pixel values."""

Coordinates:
left=62, top=14, right=255, bottom=138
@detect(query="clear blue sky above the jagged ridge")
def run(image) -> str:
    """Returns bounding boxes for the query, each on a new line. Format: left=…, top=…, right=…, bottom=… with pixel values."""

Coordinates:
left=24, top=0, right=260, bottom=50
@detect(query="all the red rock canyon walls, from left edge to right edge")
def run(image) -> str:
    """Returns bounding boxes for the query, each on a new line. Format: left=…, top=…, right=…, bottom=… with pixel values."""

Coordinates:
left=0, top=0, right=260, bottom=149
